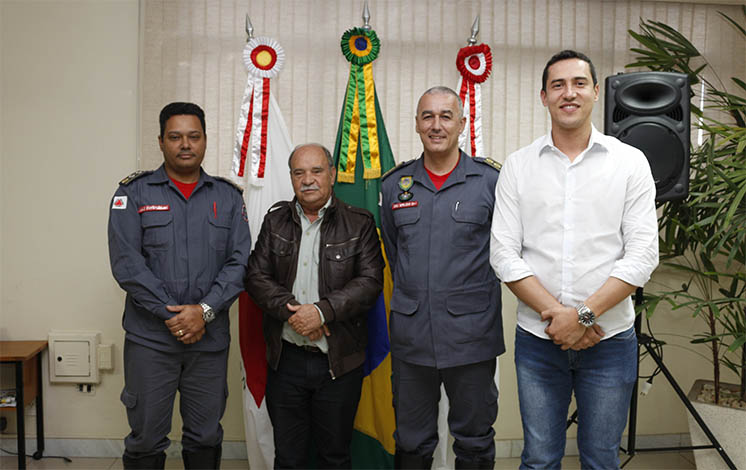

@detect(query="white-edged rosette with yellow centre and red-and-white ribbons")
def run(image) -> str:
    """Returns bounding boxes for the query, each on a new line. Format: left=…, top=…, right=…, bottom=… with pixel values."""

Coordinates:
left=233, top=36, right=285, bottom=186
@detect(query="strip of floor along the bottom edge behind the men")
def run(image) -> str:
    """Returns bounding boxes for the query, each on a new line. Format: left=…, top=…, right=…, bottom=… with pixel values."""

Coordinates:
left=0, top=452, right=696, bottom=470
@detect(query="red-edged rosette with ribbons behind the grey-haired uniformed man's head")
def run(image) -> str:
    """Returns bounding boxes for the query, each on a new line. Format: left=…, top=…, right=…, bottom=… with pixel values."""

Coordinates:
left=456, top=44, right=492, bottom=157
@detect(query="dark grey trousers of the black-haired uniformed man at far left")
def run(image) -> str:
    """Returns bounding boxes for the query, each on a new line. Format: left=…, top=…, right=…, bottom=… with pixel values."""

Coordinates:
left=121, top=341, right=228, bottom=459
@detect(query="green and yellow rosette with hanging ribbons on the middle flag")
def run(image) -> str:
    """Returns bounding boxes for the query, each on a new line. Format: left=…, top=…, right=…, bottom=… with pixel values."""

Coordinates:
left=337, top=28, right=381, bottom=183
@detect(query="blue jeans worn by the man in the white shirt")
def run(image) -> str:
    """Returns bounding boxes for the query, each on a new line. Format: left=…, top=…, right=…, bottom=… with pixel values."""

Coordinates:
left=515, top=327, right=637, bottom=469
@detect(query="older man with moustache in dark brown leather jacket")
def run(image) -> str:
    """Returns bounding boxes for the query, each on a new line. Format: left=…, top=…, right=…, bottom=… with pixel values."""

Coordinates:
left=246, top=144, right=383, bottom=468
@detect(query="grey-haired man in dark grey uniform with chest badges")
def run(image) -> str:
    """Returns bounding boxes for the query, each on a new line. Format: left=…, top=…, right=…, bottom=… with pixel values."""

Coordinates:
left=381, top=87, right=505, bottom=468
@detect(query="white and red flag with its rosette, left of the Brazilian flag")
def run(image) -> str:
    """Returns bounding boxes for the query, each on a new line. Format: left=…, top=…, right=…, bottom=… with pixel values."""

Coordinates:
left=231, top=37, right=293, bottom=470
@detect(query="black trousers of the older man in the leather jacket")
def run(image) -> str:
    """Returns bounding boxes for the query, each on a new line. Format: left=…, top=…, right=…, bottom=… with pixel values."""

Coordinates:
left=267, top=342, right=363, bottom=468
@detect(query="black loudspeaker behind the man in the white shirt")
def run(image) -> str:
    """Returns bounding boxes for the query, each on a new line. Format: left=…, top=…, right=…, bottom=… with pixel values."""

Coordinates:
left=604, top=72, right=690, bottom=202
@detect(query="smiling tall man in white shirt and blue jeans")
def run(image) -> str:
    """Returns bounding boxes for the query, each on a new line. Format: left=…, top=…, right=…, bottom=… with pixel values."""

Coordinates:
left=490, top=51, right=658, bottom=468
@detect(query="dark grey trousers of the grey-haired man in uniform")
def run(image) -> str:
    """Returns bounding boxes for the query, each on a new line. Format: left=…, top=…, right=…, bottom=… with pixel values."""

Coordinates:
left=391, top=357, right=497, bottom=462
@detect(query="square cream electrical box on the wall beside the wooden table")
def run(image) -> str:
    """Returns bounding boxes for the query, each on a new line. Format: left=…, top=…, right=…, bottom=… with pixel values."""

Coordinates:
left=49, top=331, right=101, bottom=384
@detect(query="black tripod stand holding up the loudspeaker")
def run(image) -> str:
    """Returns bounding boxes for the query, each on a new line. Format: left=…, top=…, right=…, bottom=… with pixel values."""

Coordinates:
left=567, top=287, right=737, bottom=470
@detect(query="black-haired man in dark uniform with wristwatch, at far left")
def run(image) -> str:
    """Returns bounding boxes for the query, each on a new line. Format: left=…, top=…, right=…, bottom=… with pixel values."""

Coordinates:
left=109, top=103, right=251, bottom=468
